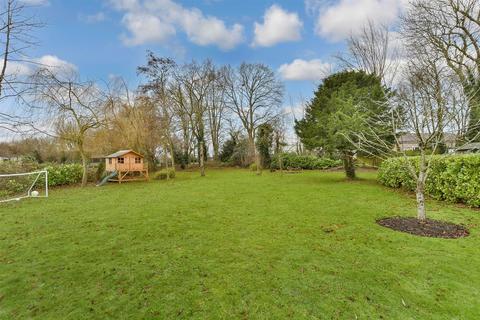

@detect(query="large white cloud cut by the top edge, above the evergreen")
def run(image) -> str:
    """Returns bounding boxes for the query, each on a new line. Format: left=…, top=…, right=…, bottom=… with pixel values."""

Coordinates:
left=316, top=0, right=407, bottom=41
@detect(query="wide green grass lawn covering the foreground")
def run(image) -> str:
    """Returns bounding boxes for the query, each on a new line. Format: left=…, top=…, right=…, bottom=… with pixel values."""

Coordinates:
left=0, top=170, right=480, bottom=319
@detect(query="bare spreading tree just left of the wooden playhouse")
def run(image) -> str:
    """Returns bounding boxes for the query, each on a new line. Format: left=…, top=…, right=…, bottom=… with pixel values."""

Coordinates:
left=32, top=68, right=105, bottom=186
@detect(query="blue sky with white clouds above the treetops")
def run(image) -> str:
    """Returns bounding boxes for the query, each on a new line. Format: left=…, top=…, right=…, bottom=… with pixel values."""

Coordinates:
left=23, top=0, right=405, bottom=109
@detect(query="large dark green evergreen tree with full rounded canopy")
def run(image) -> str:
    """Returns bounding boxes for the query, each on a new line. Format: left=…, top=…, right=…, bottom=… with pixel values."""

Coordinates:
left=295, top=71, right=388, bottom=178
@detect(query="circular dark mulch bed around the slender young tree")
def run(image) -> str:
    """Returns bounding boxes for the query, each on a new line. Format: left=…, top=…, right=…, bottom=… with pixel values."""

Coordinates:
left=377, top=217, right=470, bottom=239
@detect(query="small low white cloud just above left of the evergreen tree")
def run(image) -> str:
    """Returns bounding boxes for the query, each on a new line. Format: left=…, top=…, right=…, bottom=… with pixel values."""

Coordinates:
left=278, top=59, right=333, bottom=81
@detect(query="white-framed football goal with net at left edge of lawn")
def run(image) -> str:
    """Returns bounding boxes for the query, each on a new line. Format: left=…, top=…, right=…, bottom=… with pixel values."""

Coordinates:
left=0, top=171, right=48, bottom=203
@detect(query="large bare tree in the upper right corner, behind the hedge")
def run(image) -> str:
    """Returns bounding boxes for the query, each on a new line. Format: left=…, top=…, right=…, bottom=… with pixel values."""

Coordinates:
left=403, top=0, right=480, bottom=140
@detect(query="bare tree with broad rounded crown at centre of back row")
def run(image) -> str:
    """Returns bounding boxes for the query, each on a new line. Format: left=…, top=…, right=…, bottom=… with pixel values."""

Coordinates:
left=226, top=63, right=283, bottom=173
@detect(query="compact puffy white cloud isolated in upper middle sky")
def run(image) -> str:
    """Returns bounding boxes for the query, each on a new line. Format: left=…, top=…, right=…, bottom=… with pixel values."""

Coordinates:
left=253, top=5, right=303, bottom=47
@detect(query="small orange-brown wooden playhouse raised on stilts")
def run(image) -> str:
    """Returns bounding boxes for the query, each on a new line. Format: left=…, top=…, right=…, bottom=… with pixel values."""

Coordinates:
left=105, top=150, right=148, bottom=183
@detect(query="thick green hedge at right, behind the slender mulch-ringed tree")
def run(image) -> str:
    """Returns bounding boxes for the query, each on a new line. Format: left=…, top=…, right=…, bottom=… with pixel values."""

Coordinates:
left=378, top=154, right=480, bottom=207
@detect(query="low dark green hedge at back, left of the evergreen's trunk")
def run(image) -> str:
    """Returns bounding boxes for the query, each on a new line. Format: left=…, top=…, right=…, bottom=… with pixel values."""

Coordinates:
left=270, top=153, right=342, bottom=170
